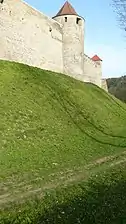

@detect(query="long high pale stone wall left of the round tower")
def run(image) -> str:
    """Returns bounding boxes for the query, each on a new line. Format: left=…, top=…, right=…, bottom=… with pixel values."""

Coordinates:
left=0, top=0, right=63, bottom=72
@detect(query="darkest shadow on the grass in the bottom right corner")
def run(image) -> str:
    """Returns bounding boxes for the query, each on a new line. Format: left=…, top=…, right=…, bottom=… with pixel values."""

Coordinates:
left=35, top=180, right=126, bottom=224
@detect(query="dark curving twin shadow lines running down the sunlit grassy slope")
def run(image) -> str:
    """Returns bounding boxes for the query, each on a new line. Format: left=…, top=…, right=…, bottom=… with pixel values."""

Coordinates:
left=41, top=80, right=126, bottom=148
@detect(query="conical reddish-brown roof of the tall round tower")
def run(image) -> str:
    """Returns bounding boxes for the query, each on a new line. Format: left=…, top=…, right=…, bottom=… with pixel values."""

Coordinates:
left=56, top=1, right=78, bottom=16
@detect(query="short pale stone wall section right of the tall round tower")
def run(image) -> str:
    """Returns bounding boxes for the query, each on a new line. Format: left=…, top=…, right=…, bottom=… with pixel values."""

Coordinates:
left=83, top=55, right=102, bottom=87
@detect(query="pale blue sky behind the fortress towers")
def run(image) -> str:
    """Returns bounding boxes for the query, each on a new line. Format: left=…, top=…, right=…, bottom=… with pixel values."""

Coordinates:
left=25, top=0, right=126, bottom=78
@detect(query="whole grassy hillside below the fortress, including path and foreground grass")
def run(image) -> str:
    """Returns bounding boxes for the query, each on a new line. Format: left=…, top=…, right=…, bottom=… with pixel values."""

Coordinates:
left=0, top=61, right=126, bottom=224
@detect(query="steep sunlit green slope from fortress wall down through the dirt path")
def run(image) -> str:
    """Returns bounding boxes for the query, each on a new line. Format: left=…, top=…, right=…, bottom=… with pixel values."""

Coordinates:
left=0, top=61, right=126, bottom=223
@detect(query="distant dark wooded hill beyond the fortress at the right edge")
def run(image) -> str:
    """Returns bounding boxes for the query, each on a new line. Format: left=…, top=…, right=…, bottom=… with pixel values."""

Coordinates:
left=107, top=76, right=126, bottom=103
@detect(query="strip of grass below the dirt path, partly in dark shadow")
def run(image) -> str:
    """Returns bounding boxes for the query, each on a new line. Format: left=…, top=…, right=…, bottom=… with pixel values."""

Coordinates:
left=0, top=166, right=126, bottom=224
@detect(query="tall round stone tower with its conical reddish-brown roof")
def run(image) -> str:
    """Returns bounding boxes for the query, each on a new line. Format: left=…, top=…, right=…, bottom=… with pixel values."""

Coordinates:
left=53, top=1, right=84, bottom=78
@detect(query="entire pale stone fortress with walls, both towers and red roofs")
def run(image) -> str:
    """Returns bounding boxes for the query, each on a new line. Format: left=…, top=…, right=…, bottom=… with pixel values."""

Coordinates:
left=0, top=0, right=108, bottom=91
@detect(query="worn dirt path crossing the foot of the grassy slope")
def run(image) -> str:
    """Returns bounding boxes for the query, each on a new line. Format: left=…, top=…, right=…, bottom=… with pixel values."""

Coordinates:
left=0, top=151, right=126, bottom=208
